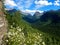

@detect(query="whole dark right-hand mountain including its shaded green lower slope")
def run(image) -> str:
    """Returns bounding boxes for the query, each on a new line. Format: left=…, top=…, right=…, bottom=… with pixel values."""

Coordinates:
left=32, top=10, right=60, bottom=37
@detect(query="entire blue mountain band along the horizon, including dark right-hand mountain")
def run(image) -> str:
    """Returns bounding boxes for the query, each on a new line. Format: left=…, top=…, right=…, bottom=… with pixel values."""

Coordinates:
left=7, top=9, right=60, bottom=23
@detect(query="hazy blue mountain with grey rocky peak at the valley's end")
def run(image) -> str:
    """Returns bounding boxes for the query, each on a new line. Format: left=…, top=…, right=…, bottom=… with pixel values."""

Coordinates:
left=24, top=12, right=43, bottom=23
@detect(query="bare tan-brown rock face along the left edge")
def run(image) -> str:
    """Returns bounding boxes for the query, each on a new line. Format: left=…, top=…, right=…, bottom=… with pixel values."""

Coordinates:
left=0, top=0, right=7, bottom=45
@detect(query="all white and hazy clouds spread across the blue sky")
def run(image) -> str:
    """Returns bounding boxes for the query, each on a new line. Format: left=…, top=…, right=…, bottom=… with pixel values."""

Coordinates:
left=4, top=0, right=60, bottom=13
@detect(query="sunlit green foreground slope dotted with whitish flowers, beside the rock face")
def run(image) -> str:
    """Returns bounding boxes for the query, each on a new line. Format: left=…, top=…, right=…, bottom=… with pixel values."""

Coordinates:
left=3, top=11, right=60, bottom=45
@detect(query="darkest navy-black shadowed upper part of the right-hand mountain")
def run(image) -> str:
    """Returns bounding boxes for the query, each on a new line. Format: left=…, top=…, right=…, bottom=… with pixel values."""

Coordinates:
left=40, top=11, right=60, bottom=23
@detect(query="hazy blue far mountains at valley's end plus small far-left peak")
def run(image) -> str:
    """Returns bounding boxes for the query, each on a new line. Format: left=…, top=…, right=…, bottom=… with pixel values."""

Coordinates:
left=7, top=9, right=43, bottom=23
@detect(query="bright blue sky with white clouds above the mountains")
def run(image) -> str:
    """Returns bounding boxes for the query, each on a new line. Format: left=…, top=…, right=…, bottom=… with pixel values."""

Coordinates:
left=4, top=0, right=60, bottom=14
